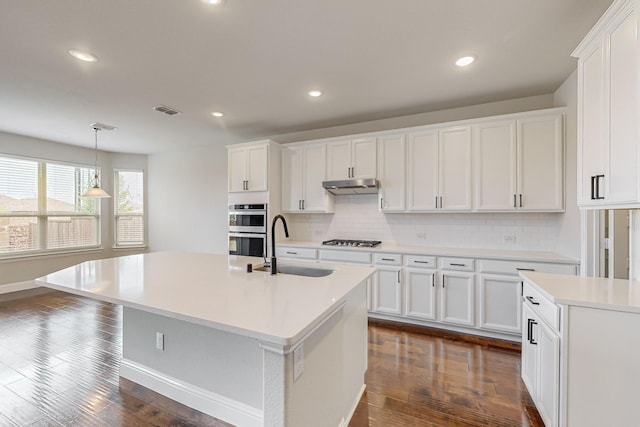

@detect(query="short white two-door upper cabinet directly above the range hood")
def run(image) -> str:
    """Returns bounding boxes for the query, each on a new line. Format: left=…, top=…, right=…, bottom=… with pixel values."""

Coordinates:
left=327, top=137, right=377, bottom=181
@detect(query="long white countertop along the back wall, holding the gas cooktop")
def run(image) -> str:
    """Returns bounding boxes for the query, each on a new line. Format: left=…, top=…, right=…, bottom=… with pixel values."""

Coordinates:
left=278, top=240, right=580, bottom=265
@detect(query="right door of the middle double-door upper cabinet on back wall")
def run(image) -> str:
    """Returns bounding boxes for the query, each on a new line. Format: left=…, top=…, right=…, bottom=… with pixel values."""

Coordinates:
left=438, top=126, right=471, bottom=211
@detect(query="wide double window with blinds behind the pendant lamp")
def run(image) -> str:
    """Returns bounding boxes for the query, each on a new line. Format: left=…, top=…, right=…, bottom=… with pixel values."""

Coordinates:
left=0, top=155, right=100, bottom=257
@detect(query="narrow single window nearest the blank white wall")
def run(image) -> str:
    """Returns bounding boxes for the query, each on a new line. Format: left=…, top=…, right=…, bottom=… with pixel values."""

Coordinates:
left=114, top=170, right=145, bottom=247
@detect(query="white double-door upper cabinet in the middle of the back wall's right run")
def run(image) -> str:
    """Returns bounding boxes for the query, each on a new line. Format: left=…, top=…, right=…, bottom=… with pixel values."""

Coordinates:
left=407, top=126, right=471, bottom=211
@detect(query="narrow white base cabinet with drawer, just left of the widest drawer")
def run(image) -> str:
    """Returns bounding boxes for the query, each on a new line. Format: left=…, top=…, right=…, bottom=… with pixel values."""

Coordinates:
left=440, top=258, right=475, bottom=326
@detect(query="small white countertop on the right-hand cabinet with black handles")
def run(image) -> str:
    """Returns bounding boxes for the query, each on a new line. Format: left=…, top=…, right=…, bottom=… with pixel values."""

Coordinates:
left=520, top=272, right=640, bottom=313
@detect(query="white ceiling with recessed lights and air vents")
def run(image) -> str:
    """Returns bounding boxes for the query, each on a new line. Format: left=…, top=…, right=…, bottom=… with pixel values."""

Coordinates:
left=0, top=0, right=611, bottom=153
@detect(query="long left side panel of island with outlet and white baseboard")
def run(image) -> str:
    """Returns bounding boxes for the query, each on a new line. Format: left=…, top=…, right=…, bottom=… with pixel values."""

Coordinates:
left=121, top=307, right=263, bottom=425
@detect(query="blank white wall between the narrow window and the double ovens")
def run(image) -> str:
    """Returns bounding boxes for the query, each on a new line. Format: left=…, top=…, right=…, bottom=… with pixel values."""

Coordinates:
left=148, top=145, right=228, bottom=253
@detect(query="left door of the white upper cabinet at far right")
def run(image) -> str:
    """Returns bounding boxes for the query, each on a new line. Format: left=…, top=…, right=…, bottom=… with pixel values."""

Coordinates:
left=578, top=41, right=608, bottom=206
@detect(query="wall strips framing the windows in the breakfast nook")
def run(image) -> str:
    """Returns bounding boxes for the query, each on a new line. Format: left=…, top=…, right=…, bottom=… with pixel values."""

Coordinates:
left=0, top=132, right=147, bottom=293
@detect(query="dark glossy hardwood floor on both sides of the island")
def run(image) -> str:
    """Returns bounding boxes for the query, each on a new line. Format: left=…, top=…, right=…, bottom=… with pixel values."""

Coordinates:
left=0, top=292, right=543, bottom=427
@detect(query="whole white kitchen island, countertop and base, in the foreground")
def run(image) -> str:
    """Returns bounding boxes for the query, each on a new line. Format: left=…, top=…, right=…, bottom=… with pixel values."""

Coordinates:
left=36, top=252, right=374, bottom=426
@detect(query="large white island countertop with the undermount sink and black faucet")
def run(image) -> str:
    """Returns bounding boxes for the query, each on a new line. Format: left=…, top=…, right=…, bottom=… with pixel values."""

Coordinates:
left=36, top=252, right=375, bottom=346
